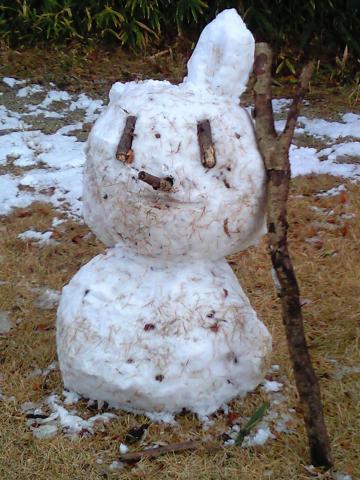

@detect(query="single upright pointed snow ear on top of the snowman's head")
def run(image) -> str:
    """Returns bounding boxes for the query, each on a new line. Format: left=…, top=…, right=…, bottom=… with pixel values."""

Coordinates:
left=185, top=8, right=255, bottom=96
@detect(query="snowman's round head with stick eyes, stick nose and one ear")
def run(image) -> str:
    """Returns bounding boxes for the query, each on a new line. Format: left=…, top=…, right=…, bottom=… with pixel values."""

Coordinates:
left=83, top=10, right=265, bottom=258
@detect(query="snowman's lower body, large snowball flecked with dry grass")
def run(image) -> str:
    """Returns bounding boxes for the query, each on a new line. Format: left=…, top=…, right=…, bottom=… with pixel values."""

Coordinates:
left=57, top=247, right=271, bottom=418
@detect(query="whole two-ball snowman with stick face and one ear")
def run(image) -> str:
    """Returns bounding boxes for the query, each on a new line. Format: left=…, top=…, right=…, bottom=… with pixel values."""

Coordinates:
left=57, top=9, right=271, bottom=414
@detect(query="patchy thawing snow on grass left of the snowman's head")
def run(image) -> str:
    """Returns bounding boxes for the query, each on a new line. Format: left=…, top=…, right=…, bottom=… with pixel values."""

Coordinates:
left=0, top=77, right=103, bottom=218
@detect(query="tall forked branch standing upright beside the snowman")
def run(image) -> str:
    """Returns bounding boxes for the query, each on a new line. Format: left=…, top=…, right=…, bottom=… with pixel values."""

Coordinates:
left=254, top=43, right=332, bottom=469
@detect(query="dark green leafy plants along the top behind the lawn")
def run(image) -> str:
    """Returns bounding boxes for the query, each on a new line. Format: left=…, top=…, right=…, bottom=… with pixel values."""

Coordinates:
left=0, top=0, right=360, bottom=57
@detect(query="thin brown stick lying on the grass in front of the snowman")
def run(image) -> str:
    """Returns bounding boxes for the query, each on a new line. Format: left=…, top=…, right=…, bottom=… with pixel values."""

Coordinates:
left=119, top=440, right=220, bottom=462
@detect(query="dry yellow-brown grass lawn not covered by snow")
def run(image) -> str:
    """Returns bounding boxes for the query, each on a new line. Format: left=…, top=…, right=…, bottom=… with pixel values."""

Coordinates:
left=0, top=44, right=360, bottom=480
